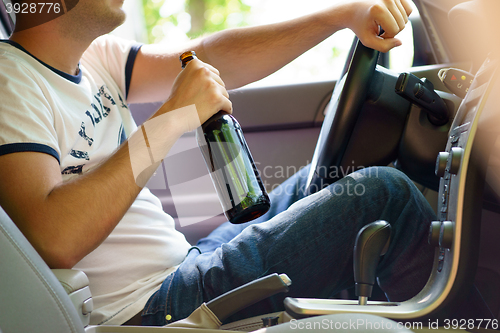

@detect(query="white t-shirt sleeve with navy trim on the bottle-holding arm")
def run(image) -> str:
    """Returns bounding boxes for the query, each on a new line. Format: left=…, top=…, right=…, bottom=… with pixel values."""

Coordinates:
left=0, top=59, right=61, bottom=161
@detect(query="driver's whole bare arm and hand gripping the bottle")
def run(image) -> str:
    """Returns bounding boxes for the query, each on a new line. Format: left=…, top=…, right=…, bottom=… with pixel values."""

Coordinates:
left=0, top=60, right=231, bottom=268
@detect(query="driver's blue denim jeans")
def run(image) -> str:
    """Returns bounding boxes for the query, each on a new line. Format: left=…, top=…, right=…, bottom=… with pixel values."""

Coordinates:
left=142, top=167, right=436, bottom=325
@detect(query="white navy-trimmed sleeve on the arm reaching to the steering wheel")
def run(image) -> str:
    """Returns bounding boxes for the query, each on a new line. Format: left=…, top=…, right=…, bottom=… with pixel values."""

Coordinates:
left=84, top=35, right=142, bottom=101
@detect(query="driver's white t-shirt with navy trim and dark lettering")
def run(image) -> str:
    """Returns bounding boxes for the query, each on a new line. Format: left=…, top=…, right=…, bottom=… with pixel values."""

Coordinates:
left=0, top=36, right=190, bottom=325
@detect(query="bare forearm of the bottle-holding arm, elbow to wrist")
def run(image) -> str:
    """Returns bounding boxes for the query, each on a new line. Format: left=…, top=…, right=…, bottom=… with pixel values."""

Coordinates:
left=18, top=109, right=188, bottom=268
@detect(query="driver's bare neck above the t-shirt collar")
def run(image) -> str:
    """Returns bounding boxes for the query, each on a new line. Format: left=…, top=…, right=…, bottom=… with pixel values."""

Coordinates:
left=9, top=27, right=92, bottom=75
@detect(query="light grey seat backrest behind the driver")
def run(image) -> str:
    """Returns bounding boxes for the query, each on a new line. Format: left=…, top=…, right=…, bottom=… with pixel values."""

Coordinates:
left=0, top=207, right=84, bottom=333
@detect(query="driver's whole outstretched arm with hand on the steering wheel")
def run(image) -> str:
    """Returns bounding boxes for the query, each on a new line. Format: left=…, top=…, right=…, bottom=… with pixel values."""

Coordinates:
left=128, top=0, right=412, bottom=102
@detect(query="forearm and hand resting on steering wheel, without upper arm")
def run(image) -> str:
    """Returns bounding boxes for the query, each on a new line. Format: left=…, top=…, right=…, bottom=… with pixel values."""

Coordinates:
left=195, top=0, right=412, bottom=89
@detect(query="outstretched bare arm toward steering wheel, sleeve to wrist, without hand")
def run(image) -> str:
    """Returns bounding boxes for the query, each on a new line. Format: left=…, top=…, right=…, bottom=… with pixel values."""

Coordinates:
left=129, top=6, right=346, bottom=103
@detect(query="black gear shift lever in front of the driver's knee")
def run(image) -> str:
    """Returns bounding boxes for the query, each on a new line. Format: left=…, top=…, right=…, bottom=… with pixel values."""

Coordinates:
left=354, top=220, right=391, bottom=305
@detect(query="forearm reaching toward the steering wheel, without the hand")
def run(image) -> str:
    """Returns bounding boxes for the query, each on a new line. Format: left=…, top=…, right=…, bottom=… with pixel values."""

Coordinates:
left=198, top=6, right=346, bottom=89
